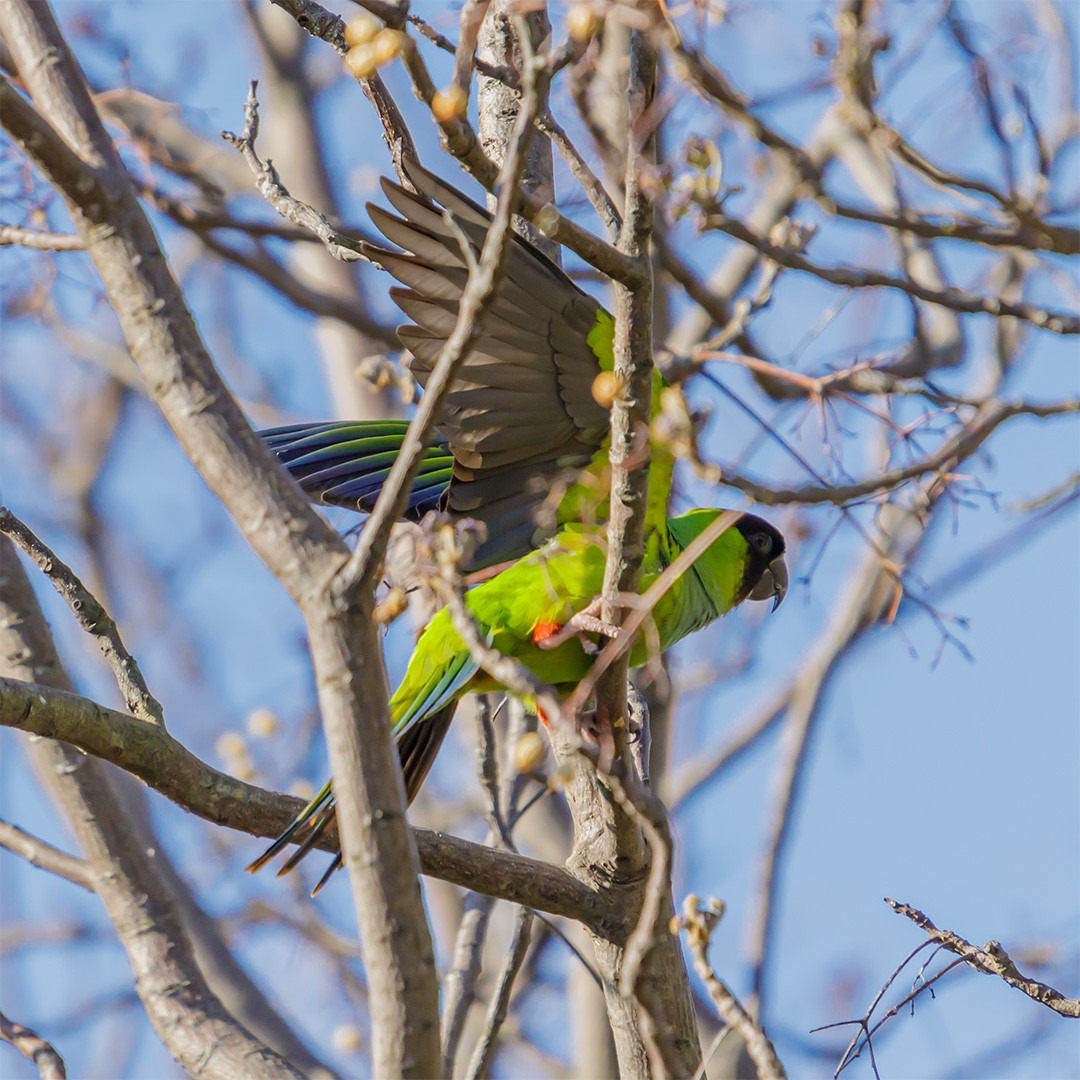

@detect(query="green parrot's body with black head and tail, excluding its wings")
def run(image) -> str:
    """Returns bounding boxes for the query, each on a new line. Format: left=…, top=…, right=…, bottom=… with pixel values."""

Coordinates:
left=247, top=510, right=787, bottom=892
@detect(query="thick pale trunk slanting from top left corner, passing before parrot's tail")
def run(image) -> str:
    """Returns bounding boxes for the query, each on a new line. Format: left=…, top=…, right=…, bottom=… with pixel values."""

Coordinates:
left=0, top=0, right=438, bottom=1076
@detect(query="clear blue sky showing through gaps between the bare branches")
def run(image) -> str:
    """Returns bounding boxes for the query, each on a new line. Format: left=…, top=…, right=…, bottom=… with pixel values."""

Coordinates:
left=0, top=2, right=1080, bottom=1078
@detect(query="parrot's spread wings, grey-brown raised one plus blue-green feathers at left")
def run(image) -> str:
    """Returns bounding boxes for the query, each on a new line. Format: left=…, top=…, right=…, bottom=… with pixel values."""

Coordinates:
left=261, top=159, right=674, bottom=569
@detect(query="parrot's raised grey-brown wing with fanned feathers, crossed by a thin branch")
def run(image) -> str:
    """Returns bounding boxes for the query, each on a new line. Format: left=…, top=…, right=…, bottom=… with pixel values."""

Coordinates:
left=367, top=160, right=612, bottom=565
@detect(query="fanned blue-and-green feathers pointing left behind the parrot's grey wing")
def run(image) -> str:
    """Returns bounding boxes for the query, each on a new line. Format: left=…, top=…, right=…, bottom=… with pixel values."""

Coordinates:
left=259, top=420, right=454, bottom=521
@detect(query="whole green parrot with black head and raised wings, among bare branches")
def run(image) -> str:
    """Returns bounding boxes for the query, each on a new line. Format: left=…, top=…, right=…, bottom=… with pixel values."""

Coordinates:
left=248, top=159, right=787, bottom=891
